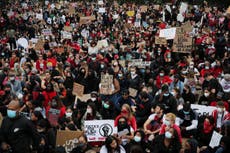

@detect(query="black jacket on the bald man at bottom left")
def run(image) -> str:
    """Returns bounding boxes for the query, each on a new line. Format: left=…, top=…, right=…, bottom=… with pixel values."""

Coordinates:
left=0, top=116, right=40, bottom=153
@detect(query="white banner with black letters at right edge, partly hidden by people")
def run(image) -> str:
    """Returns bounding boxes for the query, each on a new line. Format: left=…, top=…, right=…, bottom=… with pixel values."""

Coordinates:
left=191, top=104, right=216, bottom=116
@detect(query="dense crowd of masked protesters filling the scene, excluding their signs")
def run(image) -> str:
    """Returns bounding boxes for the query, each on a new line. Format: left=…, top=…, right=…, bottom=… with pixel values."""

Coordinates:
left=0, top=0, right=230, bottom=153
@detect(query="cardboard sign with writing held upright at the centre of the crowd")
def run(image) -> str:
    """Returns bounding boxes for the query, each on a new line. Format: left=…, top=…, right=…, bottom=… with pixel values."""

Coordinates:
left=100, top=74, right=113, bottom=95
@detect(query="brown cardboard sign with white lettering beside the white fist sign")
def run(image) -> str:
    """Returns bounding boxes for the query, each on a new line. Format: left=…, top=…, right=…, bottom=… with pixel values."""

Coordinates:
left=56, top=130, right=83, bottom=153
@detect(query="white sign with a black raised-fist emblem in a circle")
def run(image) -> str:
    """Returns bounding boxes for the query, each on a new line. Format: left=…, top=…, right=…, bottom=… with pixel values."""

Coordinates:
left=84, top=120, right=117, bottom=142
